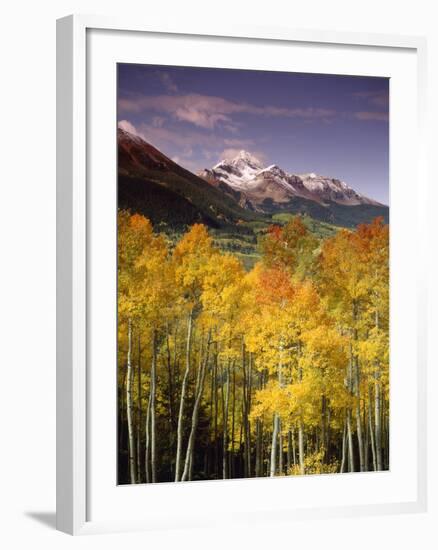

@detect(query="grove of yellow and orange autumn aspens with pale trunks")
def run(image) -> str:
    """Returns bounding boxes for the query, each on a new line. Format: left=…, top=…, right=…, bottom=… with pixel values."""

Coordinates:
left=118, top=210, right=389, bottom=484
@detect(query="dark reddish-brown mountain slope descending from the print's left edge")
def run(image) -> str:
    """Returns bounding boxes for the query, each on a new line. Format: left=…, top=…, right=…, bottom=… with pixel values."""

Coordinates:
left=117, top=128, right=264, bottom=231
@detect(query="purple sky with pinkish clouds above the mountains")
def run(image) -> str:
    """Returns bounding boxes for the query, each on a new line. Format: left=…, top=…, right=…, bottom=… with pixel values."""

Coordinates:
left=118, top=64, right=389, bottom=204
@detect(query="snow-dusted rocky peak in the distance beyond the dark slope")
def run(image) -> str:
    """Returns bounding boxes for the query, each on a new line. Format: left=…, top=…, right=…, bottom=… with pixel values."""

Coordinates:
left=198, top=151, right=380, bottom=210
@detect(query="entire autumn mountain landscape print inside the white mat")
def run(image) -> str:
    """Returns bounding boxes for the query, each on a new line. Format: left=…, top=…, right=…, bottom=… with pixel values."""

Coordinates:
left=117, top=64, right=390, bottom=485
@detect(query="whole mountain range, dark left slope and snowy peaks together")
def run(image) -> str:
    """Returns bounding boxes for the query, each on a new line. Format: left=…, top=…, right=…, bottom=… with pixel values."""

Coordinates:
left=118, top=128, right=389, bottom=233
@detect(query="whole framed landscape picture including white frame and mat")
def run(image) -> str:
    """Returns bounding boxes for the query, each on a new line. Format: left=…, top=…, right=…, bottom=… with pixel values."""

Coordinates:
left=57, top=16, right=427, bottom=534
